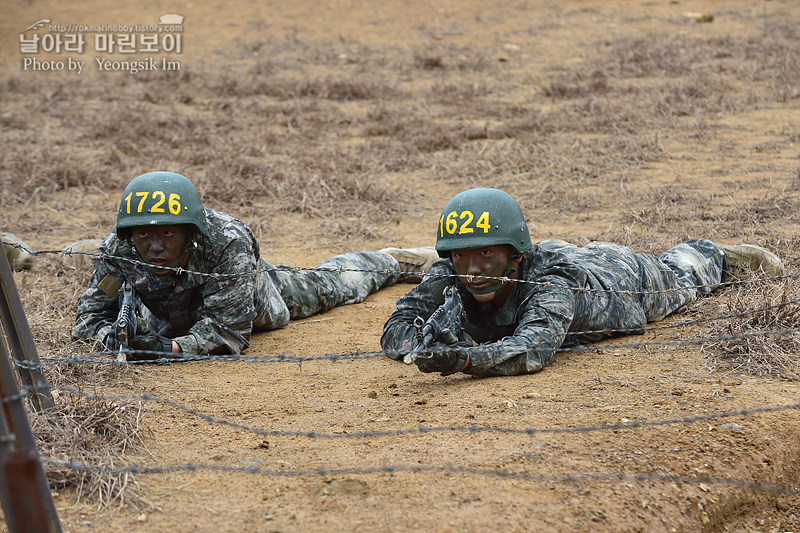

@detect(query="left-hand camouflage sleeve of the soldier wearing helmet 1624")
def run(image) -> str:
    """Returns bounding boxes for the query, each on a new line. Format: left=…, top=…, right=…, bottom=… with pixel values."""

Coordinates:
left=381, top=263, right=454, bottom=359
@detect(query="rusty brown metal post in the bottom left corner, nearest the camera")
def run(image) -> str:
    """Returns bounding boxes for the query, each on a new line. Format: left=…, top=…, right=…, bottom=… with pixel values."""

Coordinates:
left=0, top=326, right=61, bottom=533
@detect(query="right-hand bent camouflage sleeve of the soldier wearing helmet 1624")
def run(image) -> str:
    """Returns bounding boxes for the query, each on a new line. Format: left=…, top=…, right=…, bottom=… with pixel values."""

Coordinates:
left=467, top=268, right=580, bottom=376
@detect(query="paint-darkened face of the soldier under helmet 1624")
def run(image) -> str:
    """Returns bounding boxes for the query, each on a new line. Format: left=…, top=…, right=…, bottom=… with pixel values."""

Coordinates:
left=450, top=244, right=522, bottom=305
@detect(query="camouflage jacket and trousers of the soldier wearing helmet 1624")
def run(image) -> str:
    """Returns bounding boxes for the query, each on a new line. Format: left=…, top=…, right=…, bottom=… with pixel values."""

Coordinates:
left=381, top=239, right=727, bottom=376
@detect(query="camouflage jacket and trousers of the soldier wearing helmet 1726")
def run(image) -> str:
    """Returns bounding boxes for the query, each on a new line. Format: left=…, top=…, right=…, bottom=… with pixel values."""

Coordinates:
left=72, top=209, right=398, bottom=354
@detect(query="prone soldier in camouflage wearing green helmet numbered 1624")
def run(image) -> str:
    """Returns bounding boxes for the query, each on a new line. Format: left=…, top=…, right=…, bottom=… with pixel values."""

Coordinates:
left=381, top=189, right=783, bottom=376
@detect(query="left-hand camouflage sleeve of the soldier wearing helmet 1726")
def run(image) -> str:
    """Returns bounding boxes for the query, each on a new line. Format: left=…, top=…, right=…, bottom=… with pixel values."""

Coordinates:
left=72, top=236, right=125, bottom=340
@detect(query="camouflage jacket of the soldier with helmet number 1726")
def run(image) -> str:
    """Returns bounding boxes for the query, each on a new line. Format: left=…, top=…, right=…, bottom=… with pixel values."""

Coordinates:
left=72, top=209, right=289, bottom=354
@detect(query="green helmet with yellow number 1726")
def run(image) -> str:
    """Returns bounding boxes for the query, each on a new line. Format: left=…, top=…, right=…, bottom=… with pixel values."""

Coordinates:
left=116, top=171, right=208, bottom=239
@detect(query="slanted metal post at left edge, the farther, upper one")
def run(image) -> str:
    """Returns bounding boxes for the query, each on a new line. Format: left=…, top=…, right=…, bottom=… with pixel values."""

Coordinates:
left=0, top=241, right=54, bottom=411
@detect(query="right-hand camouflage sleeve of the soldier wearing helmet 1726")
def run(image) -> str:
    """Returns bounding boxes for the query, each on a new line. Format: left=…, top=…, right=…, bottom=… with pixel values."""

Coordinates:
left=174, top=228, right=256, bottom=355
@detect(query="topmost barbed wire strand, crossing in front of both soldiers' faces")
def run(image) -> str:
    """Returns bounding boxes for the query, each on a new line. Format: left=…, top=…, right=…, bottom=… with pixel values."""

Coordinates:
left=0, top=240, right=800, bottom=296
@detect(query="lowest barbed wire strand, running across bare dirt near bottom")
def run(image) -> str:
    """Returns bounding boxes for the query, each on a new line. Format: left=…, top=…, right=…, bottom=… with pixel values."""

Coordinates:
left=42, top=458, right=798, bottom=496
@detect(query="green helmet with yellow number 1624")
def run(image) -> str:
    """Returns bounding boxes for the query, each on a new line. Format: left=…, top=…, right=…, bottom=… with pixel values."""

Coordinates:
left=436, top=188, right=533, bottom=257
